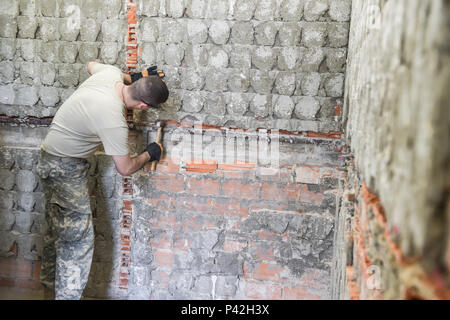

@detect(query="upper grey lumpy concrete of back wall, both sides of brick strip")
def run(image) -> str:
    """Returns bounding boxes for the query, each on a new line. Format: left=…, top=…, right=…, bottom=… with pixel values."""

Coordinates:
left=0, top=0, right=350, bottom=132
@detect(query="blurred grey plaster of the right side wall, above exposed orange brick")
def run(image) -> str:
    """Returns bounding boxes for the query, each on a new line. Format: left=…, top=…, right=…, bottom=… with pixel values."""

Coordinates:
left=344, top=0, right=450, bottom=296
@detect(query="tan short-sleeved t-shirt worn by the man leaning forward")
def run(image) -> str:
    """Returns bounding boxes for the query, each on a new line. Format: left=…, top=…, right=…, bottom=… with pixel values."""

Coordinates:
left=41, top=64, right=128, bottom=158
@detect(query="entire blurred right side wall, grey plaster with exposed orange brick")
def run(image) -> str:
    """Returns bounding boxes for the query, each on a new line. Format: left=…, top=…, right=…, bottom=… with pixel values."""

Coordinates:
left=333, top=0, right=450, bottom=299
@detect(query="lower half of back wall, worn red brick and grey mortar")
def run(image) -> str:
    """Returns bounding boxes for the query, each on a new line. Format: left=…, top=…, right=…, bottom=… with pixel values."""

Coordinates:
left=0, top=123, right=343, bottom=299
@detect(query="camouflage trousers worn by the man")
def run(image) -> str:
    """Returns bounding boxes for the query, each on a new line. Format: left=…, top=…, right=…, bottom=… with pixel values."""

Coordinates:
left=36, top=151, right=94, bottom=300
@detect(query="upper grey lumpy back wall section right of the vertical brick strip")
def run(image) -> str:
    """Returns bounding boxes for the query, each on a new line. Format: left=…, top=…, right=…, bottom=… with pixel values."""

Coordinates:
left=137, top=0, right=350, bottom=132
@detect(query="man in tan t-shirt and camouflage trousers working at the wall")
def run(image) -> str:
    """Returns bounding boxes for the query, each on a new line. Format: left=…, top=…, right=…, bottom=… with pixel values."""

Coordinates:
left=36, top=62, right=169, bottom=300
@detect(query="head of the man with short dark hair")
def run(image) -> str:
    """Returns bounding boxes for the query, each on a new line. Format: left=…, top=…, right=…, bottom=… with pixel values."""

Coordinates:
left=130, top=76, right=169, bottom=108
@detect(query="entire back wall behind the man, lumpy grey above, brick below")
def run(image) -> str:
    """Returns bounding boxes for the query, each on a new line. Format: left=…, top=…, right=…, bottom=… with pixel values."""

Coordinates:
left=0, top=0, right=350, bottom=299
